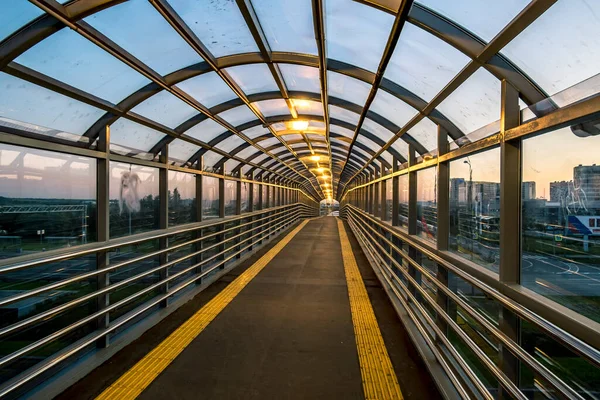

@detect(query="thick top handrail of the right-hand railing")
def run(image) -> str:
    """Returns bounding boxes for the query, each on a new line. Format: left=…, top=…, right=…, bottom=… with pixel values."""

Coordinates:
left=346, top=205, right=600, bottom=367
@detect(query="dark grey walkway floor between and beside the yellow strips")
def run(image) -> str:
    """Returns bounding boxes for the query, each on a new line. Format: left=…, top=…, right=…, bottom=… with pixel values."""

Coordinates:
left=60, top=217, right=440, bottom=399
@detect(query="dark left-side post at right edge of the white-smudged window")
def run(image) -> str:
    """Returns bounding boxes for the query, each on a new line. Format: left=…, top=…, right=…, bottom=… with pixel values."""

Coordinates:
left=158, top=145, right=169, bottom=307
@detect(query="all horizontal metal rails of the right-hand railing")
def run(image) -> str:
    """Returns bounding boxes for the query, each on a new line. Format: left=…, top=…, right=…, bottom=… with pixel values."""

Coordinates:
left=345, top=205, right=599, bottom=399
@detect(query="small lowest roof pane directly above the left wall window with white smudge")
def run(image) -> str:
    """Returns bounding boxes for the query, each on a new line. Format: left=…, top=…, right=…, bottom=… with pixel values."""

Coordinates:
left=110, top=118, right=165, bottom=154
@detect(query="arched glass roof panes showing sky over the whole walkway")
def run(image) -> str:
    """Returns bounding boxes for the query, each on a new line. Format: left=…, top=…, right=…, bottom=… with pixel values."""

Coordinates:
left=0, top=0, right=600, bottom=199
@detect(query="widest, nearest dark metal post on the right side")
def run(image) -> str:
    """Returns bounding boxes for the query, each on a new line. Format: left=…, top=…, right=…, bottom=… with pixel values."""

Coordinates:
left=499, top=80, right=522, bottom=399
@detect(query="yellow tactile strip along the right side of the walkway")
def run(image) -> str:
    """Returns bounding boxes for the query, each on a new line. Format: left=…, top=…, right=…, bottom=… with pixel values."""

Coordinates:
left=337, top=219, right=403, bottom=400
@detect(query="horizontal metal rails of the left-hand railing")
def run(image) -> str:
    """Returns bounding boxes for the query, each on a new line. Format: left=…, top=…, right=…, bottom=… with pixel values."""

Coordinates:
left=0, top=203, right=317, bottom=397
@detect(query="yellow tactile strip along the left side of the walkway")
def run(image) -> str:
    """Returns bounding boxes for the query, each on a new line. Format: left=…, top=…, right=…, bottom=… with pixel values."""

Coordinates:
left=96, top=220, right=309, bottom=400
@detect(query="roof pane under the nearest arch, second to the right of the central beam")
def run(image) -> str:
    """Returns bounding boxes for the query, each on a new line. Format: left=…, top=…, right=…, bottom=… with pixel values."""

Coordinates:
left=384, top=23, right=471, bottom=101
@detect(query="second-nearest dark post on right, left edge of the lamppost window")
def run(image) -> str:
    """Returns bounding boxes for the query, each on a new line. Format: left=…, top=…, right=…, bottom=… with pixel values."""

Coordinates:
left=436, top=125, right=450, bottom=334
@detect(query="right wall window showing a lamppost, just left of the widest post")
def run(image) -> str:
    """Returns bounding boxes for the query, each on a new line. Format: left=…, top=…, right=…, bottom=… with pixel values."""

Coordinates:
left=449, top=148, right=500, bottom=273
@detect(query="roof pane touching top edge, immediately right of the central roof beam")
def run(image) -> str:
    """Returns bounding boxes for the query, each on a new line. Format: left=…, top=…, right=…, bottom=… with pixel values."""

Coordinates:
left=325, top=0, right=394, bottom=72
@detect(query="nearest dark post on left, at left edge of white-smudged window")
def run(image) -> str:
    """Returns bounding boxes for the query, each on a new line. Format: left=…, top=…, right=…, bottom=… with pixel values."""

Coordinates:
left=96, top=125, right=110, bottom=348
